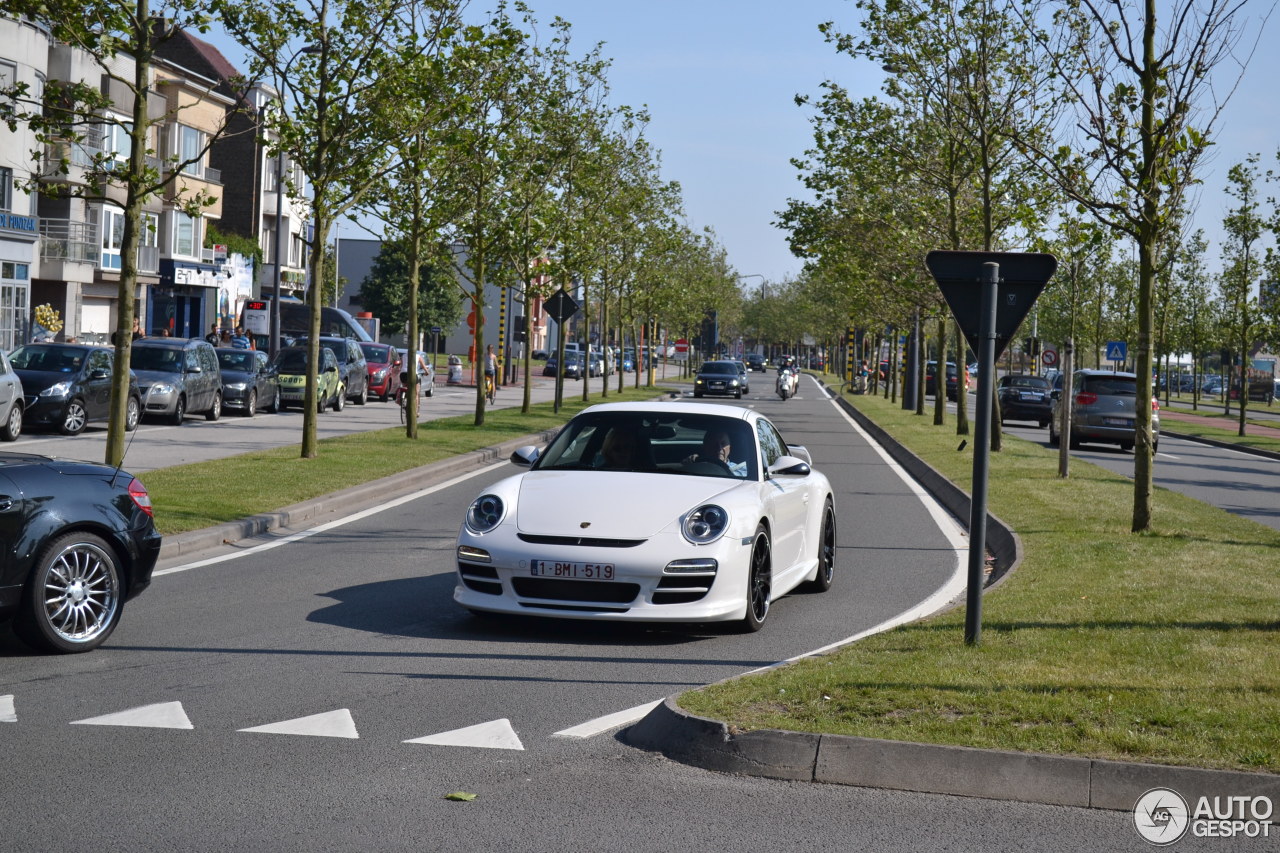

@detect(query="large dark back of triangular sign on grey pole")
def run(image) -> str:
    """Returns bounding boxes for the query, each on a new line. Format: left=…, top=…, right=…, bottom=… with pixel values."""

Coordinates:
left=924, top=251, right=1057, bottom=359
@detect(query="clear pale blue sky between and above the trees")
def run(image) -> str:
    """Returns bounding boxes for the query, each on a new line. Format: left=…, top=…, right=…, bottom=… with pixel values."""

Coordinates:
left=207, top=0, right=1280, bottom=287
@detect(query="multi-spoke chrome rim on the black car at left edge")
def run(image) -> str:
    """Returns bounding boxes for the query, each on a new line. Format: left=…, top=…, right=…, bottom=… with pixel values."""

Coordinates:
left=44, top=542, right=120, bottom=643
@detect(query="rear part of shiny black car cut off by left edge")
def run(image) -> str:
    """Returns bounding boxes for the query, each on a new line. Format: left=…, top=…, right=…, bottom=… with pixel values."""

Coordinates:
left=0, top=453, right=160, bottom=652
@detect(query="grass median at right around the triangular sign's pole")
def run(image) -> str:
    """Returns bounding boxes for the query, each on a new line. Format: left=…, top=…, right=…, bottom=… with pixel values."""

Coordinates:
left=680, top=397, right=1280, bottom=772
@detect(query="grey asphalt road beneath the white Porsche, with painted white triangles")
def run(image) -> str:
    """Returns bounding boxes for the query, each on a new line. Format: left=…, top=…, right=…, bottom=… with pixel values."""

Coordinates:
left=0, top=380, right=1212, bottom=853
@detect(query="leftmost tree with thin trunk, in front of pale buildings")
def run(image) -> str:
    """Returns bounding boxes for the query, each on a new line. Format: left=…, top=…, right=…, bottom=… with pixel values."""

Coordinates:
left=0, top=0, right=254, bottom=465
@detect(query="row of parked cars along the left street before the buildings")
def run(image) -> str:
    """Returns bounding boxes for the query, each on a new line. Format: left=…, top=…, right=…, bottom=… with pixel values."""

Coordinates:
left=0, top=336, right=434, bottom=442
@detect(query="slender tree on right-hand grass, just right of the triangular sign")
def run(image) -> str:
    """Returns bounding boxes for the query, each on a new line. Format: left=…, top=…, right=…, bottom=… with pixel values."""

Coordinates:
left=1019, top=0, right=1259, bottom=533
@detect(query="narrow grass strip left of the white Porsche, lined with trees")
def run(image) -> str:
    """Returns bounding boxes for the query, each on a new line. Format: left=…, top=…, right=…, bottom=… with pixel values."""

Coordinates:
left=141, top=387, right=660, bottom=534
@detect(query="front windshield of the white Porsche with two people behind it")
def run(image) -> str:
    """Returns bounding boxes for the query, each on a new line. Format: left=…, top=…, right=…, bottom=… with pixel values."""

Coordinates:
left=534, top=411, right=759, bottom=480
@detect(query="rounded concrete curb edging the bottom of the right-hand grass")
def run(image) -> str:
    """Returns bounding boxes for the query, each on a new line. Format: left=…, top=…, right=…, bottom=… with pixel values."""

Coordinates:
left=623, top=698, right=1280, bottom=811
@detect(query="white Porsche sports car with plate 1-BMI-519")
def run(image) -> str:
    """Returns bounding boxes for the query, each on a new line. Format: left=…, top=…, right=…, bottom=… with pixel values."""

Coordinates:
left=453, top=403, right=836, bottom=631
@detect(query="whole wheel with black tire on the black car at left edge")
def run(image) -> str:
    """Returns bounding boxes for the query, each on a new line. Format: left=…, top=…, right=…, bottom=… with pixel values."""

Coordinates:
left=14, top=532, right=124, bottom=654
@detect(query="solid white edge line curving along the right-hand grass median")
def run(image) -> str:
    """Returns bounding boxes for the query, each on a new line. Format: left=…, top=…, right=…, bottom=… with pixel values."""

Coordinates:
left=552, top=377, right=969, bottom=738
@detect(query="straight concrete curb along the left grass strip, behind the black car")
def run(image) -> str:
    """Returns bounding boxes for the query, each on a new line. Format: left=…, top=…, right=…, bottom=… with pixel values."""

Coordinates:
left=160, top=429, right=559, bottom=561
